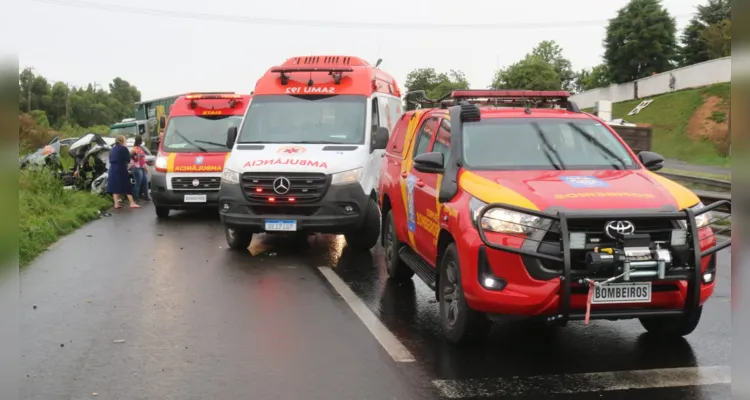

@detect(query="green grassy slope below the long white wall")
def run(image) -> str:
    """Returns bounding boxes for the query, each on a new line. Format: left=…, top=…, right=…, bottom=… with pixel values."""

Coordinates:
left=586, top=83, right=731, bottom=167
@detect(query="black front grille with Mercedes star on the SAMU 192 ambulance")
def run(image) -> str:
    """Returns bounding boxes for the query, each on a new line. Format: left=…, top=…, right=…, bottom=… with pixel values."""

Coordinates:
left=241, top=172, right=329, bottom=204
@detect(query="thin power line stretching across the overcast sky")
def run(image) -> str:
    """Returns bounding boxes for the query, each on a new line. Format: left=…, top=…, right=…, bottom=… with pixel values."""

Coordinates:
left=30, top=0, right=692, bottom=30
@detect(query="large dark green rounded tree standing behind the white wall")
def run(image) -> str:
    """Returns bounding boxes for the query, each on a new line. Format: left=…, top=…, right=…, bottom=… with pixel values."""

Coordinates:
left=604, top=0, right=678, bottom=83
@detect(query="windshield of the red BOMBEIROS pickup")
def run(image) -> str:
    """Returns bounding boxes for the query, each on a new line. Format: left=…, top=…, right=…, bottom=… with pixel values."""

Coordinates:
left=463, top=118, right=640, bottom=170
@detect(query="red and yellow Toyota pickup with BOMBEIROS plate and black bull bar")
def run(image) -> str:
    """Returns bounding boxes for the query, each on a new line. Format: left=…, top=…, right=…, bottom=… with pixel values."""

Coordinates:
left=379, top=90, right=730, bottom=343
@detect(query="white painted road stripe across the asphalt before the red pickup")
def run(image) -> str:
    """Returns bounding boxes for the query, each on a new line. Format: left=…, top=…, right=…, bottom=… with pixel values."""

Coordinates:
left=432, top=366, right=732, bottom=399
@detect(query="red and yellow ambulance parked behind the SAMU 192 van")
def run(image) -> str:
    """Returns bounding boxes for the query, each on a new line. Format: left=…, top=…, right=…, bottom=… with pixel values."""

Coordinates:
left=151, top=93, right=251, bottom=218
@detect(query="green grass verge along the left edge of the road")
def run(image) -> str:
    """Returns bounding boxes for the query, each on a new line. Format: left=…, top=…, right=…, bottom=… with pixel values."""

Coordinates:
left=18, top=170, right=112, bottom=267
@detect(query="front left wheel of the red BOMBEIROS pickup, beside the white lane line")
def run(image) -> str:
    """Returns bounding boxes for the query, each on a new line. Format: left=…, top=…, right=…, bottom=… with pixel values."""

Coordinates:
left=438, top=243, right=491, bottom=345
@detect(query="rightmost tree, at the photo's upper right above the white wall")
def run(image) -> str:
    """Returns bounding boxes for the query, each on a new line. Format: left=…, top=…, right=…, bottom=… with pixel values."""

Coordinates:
left=680, top=0, right=732, bottom=66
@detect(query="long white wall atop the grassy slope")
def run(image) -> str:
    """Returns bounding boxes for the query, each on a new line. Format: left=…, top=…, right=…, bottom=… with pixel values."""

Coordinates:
left=570, top=57, right=732, bottom=108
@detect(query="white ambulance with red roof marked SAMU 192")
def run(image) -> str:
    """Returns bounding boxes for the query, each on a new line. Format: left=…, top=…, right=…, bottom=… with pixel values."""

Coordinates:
left=219, top=55, right=402, bottom=250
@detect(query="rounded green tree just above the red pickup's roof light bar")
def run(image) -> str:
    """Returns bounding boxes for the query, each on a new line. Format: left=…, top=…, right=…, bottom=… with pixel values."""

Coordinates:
left=492, top=55, right=561, bottom=90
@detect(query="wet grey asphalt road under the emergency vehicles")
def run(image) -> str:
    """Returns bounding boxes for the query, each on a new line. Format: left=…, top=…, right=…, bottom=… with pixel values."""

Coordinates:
left=21, top=206, right=731, bottom=400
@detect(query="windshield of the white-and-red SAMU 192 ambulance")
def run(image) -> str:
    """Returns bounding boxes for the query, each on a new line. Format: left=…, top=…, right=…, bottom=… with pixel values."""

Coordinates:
left=238, top=95, right=367, bottom=144
